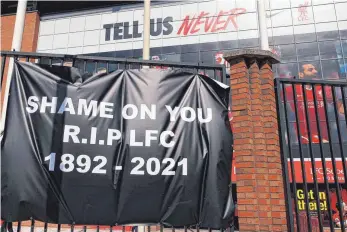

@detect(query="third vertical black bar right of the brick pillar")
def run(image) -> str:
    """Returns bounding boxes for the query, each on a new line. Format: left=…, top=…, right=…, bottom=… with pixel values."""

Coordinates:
left=291, top=84, right=312, bottom=231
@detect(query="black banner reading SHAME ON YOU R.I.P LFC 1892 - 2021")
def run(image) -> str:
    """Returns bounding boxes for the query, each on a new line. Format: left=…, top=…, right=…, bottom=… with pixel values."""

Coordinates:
left=1, top=62, right=233, bottom=228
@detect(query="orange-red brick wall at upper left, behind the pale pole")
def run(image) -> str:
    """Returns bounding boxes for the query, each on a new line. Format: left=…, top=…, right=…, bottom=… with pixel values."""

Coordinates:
left=0, top=12, right=40, bottom=114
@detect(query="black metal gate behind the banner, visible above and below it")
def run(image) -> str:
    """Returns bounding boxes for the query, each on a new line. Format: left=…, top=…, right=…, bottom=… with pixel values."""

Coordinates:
left=1, top=51, right=236, bottom=232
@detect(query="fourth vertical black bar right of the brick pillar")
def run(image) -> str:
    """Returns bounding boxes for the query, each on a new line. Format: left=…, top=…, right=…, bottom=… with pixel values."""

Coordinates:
left=301, top=82, right=329, bottom=232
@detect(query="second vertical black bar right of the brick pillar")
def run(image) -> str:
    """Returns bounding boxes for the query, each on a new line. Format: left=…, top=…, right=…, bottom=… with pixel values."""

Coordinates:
left=277, top=81, right=300, bottom=231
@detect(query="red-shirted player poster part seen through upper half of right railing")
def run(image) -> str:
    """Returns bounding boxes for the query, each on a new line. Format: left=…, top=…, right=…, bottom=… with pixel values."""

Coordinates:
left=281, top=78, right=347, bottom=158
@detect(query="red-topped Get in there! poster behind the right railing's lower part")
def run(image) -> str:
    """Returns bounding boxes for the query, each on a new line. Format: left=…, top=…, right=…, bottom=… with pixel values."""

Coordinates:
left=288, top=159, right=347, bottom=228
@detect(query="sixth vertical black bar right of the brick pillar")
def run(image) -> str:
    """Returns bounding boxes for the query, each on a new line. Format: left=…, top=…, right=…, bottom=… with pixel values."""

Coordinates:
left=322, top=85, right=345, bottom=231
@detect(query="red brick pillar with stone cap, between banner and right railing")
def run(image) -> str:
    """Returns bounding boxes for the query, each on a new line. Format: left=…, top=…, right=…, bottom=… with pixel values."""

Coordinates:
left=224, top=49, right=287, bottom=231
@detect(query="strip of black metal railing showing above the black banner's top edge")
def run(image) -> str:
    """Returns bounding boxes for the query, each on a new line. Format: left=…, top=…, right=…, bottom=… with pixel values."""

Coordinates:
left=1, top=51, right=228, bottom=84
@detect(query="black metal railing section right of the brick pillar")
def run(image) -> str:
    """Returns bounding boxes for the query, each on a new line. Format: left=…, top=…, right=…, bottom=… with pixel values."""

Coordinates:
left=275, top=79, right=347, bottom=232
